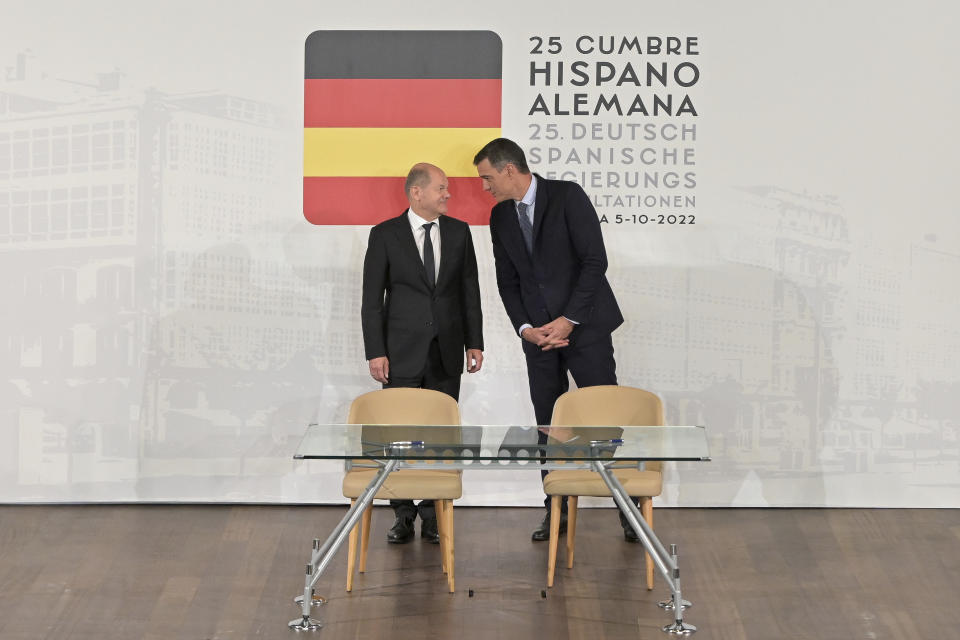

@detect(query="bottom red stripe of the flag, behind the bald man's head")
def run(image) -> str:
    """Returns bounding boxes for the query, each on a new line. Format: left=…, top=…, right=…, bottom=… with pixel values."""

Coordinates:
left=303, top=177, right=494, bottom=225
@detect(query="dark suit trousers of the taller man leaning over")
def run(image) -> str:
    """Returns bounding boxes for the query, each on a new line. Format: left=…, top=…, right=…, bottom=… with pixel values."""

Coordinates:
left=523, top=328, right=636, bottom=519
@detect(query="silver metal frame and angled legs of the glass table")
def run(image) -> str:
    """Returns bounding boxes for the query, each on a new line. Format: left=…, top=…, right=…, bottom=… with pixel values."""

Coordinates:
left=288, top=430, right=709, bottom=636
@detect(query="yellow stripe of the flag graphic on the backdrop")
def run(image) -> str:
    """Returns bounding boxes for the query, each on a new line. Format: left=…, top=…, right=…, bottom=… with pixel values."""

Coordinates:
left=303, top=128, right=500, bottom=178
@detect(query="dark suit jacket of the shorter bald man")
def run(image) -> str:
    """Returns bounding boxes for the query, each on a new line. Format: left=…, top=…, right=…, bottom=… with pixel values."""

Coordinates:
left=360, top=211, right=483, bottom=377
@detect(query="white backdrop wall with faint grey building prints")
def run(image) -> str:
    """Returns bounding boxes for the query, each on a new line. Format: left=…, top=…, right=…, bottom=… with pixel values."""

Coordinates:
left=0, top=0, right=960, bottom=507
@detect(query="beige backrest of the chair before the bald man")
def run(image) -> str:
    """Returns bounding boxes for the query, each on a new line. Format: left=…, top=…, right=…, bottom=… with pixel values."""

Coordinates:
left=347, top=388, right=460, bottom=425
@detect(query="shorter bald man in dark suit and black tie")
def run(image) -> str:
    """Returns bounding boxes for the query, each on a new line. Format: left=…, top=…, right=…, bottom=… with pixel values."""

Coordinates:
left=360, top=163, right=483, bottom=544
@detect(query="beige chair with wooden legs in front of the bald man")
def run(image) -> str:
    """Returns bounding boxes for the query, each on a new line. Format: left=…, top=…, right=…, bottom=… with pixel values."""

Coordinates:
left=343, top=389, right=462, bottom=593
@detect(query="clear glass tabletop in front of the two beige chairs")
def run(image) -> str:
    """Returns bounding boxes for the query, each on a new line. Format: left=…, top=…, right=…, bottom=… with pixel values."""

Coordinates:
left=293, top=424, right=710, bottom=462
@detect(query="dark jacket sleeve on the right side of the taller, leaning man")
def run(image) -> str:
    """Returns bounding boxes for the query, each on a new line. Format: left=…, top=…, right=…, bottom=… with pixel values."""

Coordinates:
left=562, top=183, right=607, bottom=324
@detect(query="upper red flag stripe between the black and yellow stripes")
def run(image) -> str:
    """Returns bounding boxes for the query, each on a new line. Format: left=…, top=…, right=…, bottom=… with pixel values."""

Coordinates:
left=303, top=78, right=501, bottom=128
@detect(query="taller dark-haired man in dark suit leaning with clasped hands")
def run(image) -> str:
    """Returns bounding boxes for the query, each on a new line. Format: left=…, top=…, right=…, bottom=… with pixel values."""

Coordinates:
left=473, top=138, right=638, bottom=542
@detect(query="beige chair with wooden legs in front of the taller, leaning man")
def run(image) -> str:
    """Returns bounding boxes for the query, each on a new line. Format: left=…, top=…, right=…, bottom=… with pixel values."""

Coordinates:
left=543, top=385, right=663, bottom=589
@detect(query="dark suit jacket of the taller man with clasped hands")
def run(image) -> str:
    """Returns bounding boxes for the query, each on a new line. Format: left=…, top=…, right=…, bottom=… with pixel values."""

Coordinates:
left=490, top=176, right=623, bottom=348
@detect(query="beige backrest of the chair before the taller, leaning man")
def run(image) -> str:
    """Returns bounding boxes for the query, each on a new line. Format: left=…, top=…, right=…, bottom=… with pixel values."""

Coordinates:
left=550, top=385, right=664, bottom=471
